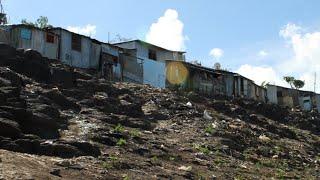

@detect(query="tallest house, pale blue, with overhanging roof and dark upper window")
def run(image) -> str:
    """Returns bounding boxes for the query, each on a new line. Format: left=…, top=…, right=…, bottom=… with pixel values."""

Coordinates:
left=114, top=40, right=185, bottom=88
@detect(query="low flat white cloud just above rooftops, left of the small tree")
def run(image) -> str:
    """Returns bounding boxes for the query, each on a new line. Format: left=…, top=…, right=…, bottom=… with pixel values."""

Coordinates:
left=236, top=64, right=283, bottom=85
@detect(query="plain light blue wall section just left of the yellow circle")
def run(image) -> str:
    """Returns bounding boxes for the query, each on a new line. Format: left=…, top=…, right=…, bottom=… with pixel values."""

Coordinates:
left=143, top=59, right=166, bottom=88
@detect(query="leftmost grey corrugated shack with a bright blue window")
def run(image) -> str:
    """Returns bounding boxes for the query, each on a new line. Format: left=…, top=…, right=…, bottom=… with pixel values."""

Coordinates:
left=0, top=24, right=60, bottom=59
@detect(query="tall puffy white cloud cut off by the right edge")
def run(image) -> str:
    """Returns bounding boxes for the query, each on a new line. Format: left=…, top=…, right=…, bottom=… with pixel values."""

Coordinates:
left=279, top=24, right=320, bottom=91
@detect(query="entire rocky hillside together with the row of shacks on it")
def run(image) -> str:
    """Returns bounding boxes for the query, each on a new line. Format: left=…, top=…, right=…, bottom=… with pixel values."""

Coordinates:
left=0, top=25, right=320, bottom=180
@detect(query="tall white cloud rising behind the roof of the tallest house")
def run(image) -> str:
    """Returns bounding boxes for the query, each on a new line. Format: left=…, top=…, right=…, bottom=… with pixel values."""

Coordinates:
left=146, top=9, right=188, bottom=51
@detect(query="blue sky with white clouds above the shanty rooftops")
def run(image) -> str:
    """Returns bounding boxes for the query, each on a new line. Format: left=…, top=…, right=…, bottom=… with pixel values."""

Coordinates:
left=3, top=0, right=320, bottom=92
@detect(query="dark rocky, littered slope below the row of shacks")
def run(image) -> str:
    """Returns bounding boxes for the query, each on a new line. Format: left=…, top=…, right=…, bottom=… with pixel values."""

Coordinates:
left=0, top=44, right=320, bottom=179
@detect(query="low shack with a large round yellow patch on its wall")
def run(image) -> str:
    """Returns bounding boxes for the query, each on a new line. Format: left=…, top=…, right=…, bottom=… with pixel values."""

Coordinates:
left=166, top=61, right=225, bottom=95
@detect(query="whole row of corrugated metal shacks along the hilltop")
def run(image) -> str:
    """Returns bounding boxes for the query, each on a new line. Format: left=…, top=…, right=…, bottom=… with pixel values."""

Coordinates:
left=0, top=24, right=320, bottom=111
